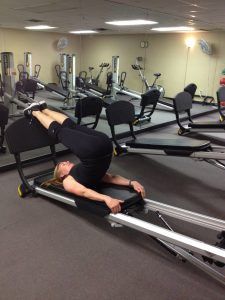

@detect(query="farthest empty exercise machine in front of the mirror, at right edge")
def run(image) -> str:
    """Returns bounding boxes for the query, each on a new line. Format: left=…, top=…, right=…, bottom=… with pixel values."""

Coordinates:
left=174, top=92, right=225, bottom=135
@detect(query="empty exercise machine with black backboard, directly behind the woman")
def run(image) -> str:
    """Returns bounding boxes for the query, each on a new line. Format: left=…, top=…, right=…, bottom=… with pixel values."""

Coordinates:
left=106, top=99, right=225, bottom=170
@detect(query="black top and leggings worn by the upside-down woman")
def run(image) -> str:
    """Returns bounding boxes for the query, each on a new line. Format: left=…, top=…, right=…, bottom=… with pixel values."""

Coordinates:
left=48, top=118, right=113, bottom=188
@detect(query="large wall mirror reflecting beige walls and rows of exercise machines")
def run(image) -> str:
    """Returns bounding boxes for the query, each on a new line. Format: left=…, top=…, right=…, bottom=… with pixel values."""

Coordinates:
left=0, top=30, right=221, bottom=170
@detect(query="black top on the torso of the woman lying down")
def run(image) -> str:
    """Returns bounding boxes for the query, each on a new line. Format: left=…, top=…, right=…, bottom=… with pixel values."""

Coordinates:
left=69, top=154, right=112, bottom=188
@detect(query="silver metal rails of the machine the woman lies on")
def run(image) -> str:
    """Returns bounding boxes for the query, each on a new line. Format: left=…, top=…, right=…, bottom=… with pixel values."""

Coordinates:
left=31, top=182, right=225, bottom=285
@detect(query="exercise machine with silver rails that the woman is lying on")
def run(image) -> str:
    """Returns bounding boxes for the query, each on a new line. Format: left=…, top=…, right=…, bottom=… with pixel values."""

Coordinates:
left=6, top=118, right=225, bottom=285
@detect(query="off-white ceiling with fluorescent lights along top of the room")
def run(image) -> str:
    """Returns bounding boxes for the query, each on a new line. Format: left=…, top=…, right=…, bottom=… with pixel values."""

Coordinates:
left=0, top=0, right=225, bottom=34
